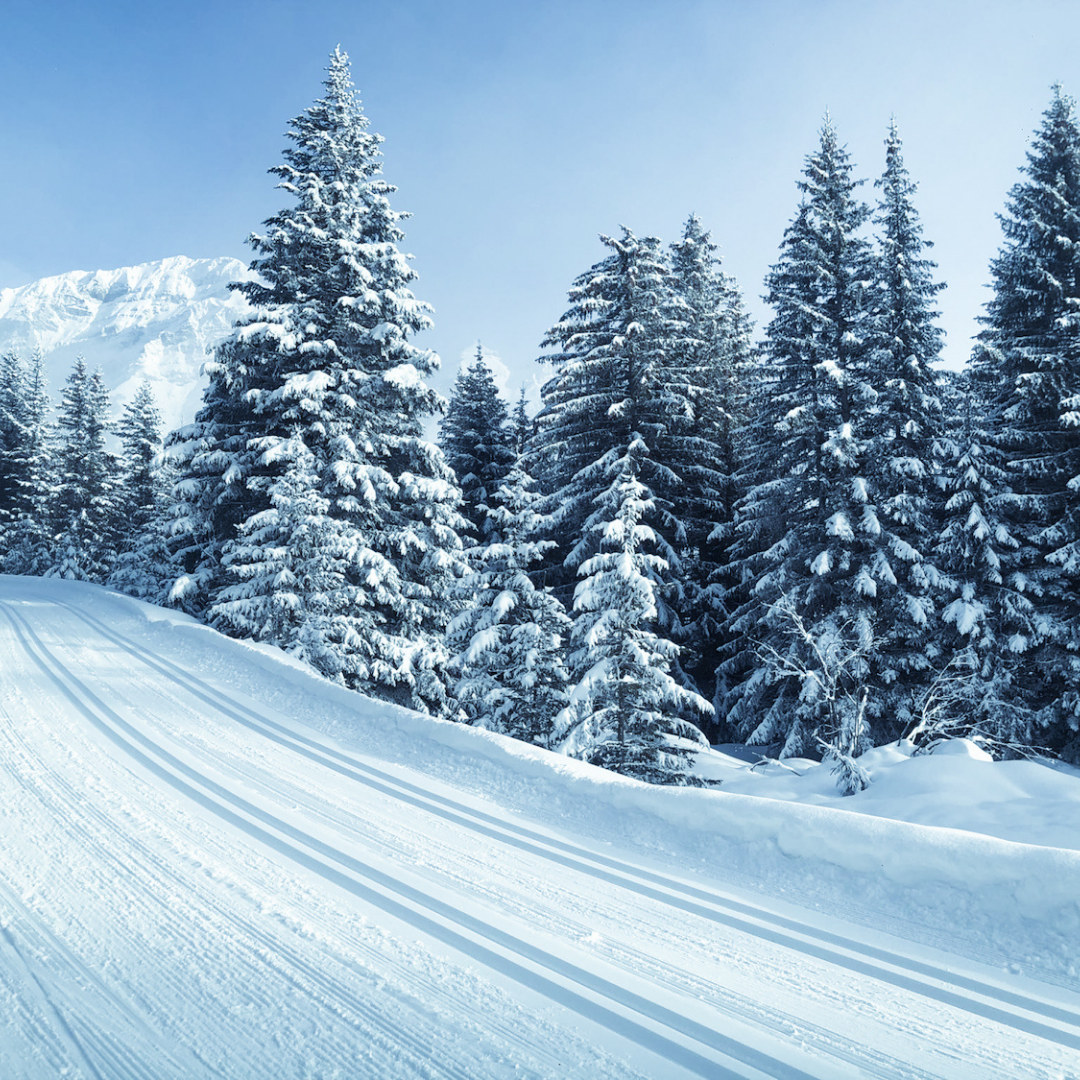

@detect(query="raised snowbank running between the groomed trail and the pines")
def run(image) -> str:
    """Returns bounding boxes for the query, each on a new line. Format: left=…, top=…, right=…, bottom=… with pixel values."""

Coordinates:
left=21, top=579, right=1080, bottom=982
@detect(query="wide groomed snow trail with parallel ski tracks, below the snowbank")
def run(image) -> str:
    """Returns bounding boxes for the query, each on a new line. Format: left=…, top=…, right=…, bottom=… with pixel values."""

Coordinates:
left=0, top=578, right=1080, bottom=1080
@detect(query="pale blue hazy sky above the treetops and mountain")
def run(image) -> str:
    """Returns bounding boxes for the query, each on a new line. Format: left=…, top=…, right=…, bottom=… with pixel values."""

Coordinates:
left=0, top=0, right=1080, bottom=392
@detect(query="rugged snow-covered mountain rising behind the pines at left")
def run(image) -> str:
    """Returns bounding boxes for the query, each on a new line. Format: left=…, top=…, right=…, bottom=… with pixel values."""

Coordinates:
left=0, top=256, right=252, bottom=431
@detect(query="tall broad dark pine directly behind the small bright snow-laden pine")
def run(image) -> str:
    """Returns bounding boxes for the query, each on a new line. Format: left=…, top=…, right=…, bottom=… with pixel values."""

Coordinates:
left=528, top=228, right=692, bottom=636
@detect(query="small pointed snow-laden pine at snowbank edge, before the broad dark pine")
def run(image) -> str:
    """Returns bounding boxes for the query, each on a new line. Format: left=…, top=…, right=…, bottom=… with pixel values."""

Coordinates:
left=555, top=433, right=712, bottom=784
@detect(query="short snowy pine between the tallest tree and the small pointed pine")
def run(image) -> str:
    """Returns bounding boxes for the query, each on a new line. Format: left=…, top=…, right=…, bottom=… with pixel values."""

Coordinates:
left=447, top=467, right=570, bottom=746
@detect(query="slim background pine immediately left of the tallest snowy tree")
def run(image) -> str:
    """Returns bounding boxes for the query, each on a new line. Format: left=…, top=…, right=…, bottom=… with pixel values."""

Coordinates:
left=108, top=382, right=176, bottom=604
